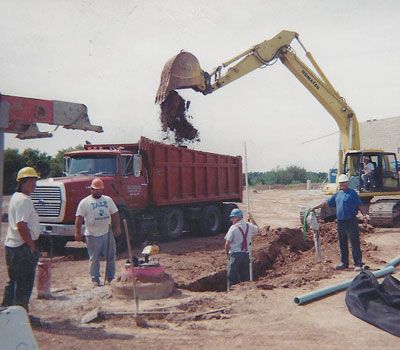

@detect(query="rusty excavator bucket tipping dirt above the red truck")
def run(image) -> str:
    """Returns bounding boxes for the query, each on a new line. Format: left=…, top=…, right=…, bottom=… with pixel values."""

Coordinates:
left=156, top=51, right=206, bottom=103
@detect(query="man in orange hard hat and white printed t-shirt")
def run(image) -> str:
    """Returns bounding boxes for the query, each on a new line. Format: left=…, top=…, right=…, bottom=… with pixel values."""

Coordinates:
left=75, top=178, right=121, bottom=286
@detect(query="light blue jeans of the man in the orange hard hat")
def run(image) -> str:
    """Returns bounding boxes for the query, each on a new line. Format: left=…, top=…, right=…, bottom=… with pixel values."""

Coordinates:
left=85, top=231, right=116, bottom=280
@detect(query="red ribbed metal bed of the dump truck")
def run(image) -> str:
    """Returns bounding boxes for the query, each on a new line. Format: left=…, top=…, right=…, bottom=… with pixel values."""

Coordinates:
left=140, top=137, right=243, bottom=206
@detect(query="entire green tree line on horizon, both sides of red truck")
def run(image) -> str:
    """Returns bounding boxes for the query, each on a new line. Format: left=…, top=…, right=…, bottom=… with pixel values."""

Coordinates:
left=3, top=145, right=327, bottom=194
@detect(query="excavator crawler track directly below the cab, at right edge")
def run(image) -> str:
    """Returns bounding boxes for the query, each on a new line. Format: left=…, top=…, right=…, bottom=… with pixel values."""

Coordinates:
left=369, top=199, right=400, bottom=227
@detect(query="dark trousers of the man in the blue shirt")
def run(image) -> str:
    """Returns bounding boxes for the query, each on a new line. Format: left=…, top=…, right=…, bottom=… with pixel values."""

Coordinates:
left=337, top=217, right=362, bottom=267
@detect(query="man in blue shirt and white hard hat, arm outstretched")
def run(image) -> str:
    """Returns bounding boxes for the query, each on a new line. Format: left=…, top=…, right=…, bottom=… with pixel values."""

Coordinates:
left=311, top=174, right=368, bottom=271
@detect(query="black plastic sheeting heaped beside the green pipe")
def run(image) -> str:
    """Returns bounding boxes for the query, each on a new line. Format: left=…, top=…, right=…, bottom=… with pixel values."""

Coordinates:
left=346, top=271, right=400, bottom=337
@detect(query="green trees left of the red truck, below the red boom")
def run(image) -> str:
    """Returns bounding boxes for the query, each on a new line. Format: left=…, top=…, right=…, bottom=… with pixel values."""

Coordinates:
left=3, top=145, right=83, bottom=194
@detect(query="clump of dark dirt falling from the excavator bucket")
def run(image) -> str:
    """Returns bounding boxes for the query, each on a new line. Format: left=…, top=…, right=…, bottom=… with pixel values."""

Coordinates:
left=160, top=91, right=200, bottom=145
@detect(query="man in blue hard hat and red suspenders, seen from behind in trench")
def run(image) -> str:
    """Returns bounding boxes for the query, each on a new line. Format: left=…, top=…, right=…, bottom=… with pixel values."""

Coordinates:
left=225, top=208, right=258, bottom=288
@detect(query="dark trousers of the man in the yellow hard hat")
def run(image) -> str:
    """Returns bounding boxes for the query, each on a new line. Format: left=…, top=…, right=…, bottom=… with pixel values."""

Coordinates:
left=2, top=243, right=40, bottom=312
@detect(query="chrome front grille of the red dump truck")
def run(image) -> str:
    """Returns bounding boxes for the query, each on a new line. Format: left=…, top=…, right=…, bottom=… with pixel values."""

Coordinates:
left=31, top=186, right=61, bottom=217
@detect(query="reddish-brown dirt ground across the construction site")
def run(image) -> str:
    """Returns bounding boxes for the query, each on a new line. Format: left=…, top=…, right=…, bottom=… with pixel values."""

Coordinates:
left=0, top=189, right=400, bottom=350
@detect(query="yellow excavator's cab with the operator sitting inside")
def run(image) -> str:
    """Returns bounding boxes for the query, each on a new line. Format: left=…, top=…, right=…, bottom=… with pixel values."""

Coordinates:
left=344, top=151, right=400, bottom=197
